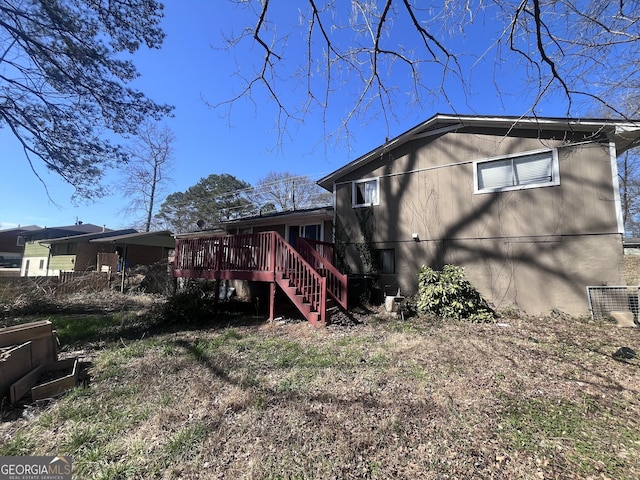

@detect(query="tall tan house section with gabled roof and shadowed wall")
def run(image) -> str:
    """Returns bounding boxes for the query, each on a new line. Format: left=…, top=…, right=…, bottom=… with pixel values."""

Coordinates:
left=318, top=114, right=640, bottom=315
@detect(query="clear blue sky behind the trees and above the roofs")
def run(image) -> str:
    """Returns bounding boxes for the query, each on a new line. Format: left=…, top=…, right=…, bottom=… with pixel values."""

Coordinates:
left=0, top=0, right=564, bottom=229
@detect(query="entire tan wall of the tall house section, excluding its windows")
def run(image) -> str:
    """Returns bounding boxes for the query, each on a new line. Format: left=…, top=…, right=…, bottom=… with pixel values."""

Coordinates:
left=336, top=134, right=624, bottom=315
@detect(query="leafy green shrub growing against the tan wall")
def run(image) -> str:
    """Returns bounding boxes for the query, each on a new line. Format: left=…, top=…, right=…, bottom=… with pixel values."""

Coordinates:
left=417, top=265, right=495, bottom=322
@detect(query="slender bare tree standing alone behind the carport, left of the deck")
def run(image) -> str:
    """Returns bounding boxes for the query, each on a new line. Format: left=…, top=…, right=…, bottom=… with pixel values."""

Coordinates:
left=121, top=122, right=175, bottom=232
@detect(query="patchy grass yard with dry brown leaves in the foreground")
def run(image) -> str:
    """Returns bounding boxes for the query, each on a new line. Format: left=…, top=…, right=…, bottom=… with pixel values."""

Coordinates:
left=0, top=294, right=640, bottom=480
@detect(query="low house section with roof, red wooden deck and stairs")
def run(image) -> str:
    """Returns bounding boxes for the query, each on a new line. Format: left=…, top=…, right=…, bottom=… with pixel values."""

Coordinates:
left=173, top=207, right=347, bottom=324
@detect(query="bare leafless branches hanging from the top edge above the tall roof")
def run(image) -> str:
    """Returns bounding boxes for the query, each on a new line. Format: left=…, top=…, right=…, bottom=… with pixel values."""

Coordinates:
left=217, top=0, right=640, bottom=142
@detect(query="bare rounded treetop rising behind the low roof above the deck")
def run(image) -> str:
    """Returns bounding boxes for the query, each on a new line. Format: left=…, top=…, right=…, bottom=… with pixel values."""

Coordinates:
left=248, top=172, right=332, bottom=212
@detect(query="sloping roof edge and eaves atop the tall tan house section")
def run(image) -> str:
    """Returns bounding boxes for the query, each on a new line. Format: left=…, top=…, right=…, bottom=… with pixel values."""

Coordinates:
left=317, top=113, right=640, bottom=191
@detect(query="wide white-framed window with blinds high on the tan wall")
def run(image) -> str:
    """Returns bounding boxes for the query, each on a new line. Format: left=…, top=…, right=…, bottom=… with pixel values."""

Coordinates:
left=473, top=149, right=560, bottom=193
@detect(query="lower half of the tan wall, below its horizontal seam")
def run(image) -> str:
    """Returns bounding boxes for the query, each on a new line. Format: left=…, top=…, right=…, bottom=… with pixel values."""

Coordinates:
left=346, top=234, right=625, bottom=315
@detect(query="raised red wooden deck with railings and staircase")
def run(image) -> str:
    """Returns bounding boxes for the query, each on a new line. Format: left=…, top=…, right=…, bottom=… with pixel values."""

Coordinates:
left=174, top=232, right=347, bottom=324
